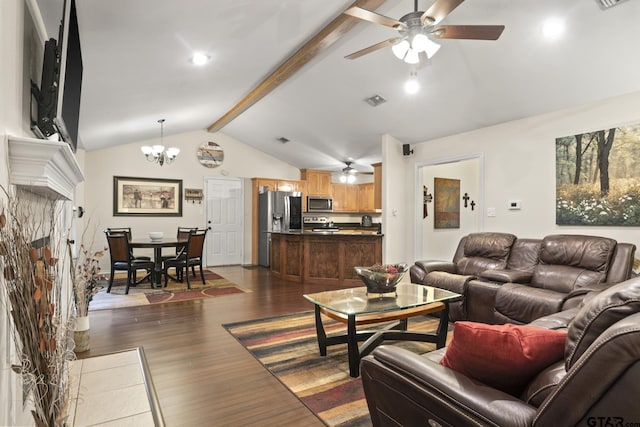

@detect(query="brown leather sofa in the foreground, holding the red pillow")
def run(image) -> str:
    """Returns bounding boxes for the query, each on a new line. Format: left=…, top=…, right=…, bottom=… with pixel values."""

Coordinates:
left=361, top=278, right=640, bottom=427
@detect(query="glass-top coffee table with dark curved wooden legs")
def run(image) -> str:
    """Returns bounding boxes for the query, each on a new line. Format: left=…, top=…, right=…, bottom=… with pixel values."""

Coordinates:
left=304, top=283, right=461, bottom=377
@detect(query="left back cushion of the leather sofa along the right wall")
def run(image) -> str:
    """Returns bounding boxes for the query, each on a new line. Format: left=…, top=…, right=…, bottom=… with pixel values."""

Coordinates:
left=456, top=233, right=516, bottom=275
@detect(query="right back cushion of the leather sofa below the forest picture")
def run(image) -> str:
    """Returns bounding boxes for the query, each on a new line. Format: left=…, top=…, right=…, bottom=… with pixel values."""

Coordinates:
left=531, top=234, right=617, bottom=293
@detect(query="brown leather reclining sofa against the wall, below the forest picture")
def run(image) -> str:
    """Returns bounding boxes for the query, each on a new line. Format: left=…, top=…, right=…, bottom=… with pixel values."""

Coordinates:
left=410, top=233, right=636, bottom=324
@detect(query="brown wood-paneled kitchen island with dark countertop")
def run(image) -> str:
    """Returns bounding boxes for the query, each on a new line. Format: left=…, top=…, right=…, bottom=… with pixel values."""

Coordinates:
left=270, top=231, right=383, bottom=288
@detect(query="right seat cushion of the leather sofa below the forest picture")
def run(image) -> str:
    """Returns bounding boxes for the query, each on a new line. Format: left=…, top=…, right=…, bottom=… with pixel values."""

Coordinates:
left=495, top=283, right=566, bottom=323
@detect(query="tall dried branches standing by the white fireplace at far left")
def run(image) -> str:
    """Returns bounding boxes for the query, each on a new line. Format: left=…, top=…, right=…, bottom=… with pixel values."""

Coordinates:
left=0, top=187, right=75, bottom=427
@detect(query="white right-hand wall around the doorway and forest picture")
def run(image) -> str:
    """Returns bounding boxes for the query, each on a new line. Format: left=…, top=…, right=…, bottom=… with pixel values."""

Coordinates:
left=382, top=92, right=640, bottom=261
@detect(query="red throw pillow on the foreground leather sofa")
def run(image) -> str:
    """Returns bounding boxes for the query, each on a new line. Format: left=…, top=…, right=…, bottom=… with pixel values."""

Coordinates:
left=440, top=322, right=567, bottom=396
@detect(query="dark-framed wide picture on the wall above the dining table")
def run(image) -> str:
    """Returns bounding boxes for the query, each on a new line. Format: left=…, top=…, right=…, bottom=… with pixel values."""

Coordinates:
left=113, top=176, right=182, bottom=216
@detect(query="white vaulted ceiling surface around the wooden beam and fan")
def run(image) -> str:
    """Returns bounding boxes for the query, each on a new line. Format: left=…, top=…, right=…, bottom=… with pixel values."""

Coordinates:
left=38, top=0, right=640, bottom=171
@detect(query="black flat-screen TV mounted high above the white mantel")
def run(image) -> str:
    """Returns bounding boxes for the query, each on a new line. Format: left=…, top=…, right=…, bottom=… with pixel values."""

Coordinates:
left=54, top=0, right=82, bottom=152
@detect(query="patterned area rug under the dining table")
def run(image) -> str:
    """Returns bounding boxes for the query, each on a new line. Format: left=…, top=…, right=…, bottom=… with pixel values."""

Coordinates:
left=89, top=268, right=250, bottom=311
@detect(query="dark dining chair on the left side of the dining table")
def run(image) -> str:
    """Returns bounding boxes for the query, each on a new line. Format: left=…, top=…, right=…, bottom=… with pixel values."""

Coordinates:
left=105, top=231, right=154, bottom=294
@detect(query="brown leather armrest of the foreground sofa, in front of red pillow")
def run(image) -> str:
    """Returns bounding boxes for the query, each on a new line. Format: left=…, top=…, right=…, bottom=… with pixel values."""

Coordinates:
left=361, top=345, right=536, bottom=426
